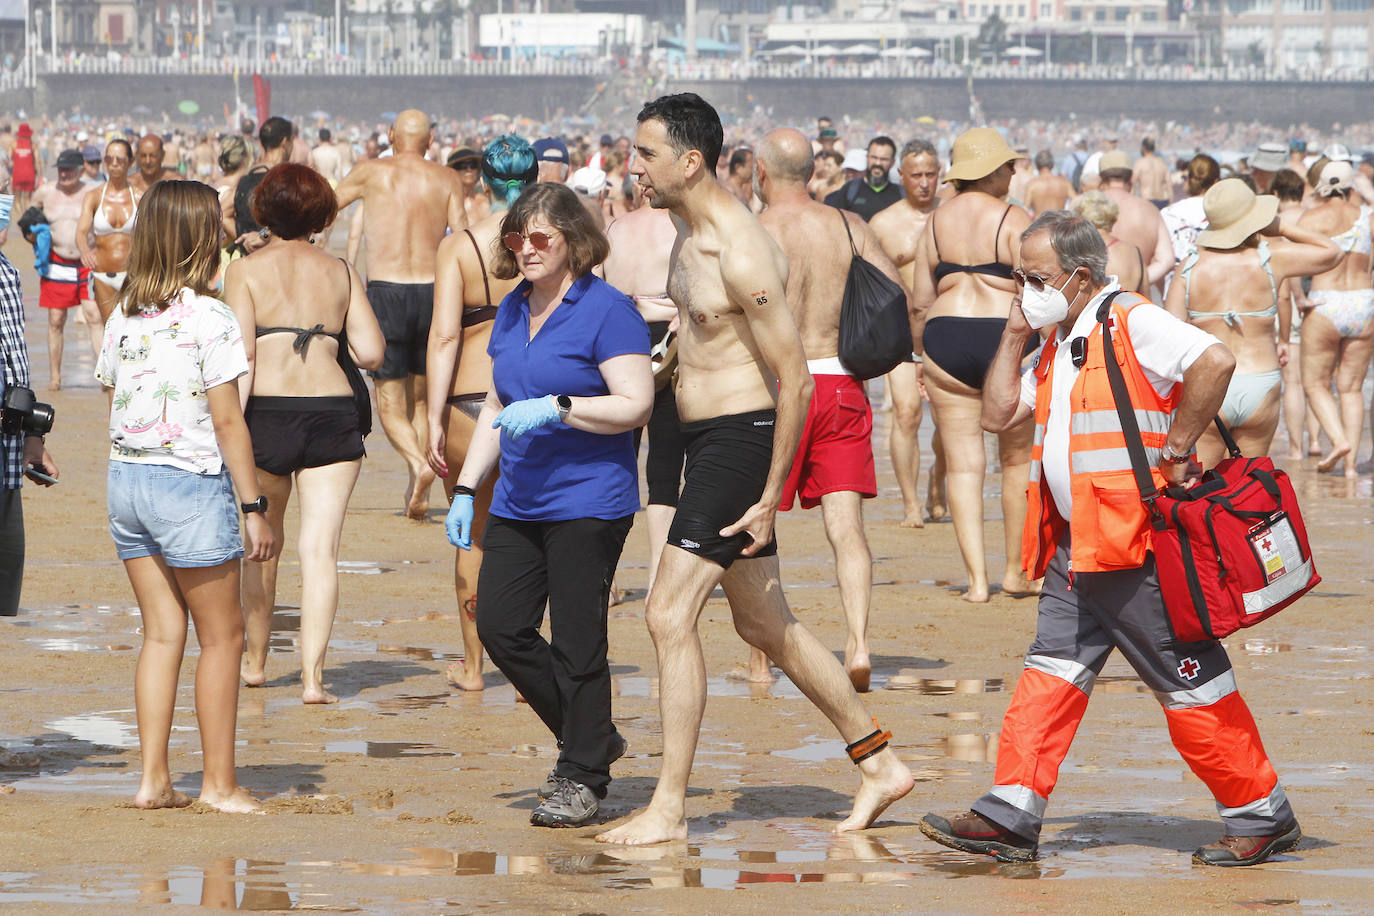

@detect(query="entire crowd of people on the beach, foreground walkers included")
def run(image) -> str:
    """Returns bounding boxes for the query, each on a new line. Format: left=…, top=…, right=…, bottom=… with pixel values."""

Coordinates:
left=0, top=93, right=1374, bottom=865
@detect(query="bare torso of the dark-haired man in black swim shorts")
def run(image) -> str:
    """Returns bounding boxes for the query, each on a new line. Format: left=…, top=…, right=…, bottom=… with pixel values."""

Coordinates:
left=668, top=201, right=787, bottom=423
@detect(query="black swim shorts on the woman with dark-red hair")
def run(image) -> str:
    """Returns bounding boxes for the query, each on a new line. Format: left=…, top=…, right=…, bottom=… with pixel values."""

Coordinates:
left=243, top=396, right=367, bottom=477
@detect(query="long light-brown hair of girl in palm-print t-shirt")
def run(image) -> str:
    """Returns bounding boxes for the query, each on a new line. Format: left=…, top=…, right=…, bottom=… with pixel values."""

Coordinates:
left=120, top=179, right=223, bottom=314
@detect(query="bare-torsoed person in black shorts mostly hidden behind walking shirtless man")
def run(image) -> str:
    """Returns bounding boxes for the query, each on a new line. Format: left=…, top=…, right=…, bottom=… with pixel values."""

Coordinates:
left=602, top=206, right=683, bottom=592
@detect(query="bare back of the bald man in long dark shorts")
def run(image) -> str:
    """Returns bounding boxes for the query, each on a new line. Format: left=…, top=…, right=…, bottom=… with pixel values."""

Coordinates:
left=363, top=154, right=459, bottom=283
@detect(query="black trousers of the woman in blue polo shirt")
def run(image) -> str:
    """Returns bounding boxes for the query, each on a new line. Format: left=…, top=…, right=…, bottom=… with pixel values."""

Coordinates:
left=477, top=515, right=635, bottom=798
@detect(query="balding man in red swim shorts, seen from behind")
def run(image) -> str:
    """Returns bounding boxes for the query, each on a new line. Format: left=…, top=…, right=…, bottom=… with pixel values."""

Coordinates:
left=750, top=128, right=915, bottom=692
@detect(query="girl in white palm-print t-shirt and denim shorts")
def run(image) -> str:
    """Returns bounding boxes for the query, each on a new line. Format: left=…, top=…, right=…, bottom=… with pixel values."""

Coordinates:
left=95, top=181, right=278, bottom=812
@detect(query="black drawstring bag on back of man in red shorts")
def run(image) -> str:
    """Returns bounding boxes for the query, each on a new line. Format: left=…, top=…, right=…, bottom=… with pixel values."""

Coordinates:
left=840, top=211, right=911, bottom=380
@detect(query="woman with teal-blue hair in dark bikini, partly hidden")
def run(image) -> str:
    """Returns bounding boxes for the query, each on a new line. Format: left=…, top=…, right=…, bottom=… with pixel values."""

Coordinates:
left=426, top=136, right=539, bottom=691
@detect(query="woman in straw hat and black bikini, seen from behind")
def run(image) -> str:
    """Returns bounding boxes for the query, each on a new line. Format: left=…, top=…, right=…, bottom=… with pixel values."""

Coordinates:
left=912, top=128, right=1033, bottom=602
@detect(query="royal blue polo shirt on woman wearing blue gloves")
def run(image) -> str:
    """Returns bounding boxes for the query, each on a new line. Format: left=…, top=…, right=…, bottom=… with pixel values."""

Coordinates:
left=486, top=273, right=649, bottom=522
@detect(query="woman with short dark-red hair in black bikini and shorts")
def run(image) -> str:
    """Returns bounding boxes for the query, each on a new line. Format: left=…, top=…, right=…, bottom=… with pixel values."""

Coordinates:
left=224, top=163, right=386, bottom=703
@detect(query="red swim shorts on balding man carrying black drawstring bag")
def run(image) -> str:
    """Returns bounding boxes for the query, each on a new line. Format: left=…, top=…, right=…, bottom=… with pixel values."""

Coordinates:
left=778, top=375, right=878, bottom=512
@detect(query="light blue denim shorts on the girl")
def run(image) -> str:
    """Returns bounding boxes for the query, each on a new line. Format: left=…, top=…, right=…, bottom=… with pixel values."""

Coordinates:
left=106, top=461, right=243, bottom=567
